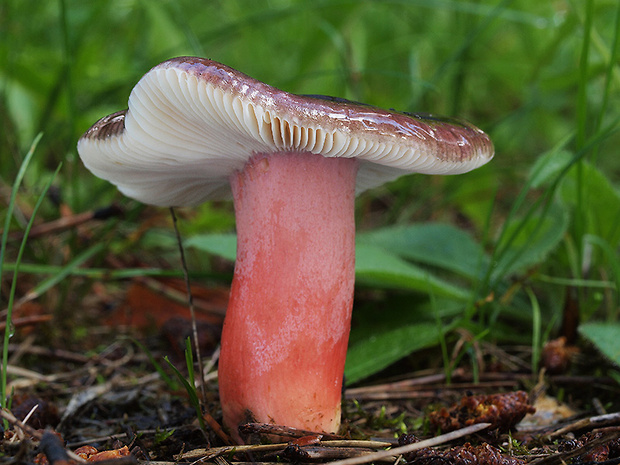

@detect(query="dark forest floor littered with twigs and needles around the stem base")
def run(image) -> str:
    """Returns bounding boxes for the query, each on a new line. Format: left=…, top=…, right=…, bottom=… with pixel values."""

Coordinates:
left=2, top=279, right=620, bottom=465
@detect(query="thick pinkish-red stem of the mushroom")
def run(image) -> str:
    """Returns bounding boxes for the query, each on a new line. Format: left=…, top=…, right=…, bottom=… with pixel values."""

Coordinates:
left=219, top=153, right=357, bottom=439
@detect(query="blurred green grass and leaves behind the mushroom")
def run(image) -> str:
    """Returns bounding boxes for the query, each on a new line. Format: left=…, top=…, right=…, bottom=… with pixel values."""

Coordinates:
left=0, top=0, right=620, bottom=381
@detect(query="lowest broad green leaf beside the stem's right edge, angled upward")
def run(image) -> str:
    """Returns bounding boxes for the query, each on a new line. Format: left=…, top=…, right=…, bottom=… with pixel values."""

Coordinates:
left=344, top=323, right=440, bottom=384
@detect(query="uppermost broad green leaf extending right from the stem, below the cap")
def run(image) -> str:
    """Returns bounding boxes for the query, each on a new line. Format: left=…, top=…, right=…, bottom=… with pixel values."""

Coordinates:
left=357, top=223, right=488, bottom=279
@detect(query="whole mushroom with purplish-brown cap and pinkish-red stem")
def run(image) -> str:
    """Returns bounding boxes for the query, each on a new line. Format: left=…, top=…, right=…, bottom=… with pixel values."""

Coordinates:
left=78, top=57, right=493, bottom=439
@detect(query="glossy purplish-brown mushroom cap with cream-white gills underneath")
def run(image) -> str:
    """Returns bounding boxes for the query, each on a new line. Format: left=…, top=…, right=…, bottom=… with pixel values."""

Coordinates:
left=78, top=57, right=494, bottom=206
